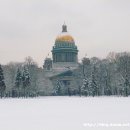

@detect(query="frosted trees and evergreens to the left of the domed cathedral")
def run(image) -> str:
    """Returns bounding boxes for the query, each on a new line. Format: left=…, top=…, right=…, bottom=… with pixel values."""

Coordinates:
left=0, top=57, right=38, bottom=98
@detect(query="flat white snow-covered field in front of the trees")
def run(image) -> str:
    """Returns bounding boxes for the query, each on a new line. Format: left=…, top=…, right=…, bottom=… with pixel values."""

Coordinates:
left=0, top=97, right=130, bottom=130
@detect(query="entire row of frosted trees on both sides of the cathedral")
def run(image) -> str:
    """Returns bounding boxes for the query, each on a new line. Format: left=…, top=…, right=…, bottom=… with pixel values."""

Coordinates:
left=0, top=52, right=130, bottom=97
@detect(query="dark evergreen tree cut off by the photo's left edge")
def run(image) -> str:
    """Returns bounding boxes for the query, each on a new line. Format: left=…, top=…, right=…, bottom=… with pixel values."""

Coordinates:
left=0, top=65, right=6, bottom=98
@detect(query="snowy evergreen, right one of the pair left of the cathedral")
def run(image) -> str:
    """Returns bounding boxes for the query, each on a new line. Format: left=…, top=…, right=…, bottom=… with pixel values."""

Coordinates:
left=22, top=67, right=31, bottom=96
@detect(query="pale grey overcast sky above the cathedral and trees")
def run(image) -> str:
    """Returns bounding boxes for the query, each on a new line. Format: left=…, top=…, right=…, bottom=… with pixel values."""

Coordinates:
left=0, top=0, right=130, bottom=66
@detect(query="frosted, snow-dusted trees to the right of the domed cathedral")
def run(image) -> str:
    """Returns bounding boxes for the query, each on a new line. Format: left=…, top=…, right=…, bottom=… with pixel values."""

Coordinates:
left=76, top=52, right=130, bottom=96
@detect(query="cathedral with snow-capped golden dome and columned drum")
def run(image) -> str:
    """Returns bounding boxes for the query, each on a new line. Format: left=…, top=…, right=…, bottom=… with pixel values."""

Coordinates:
left=43, top=24, right=79, bottom=95
